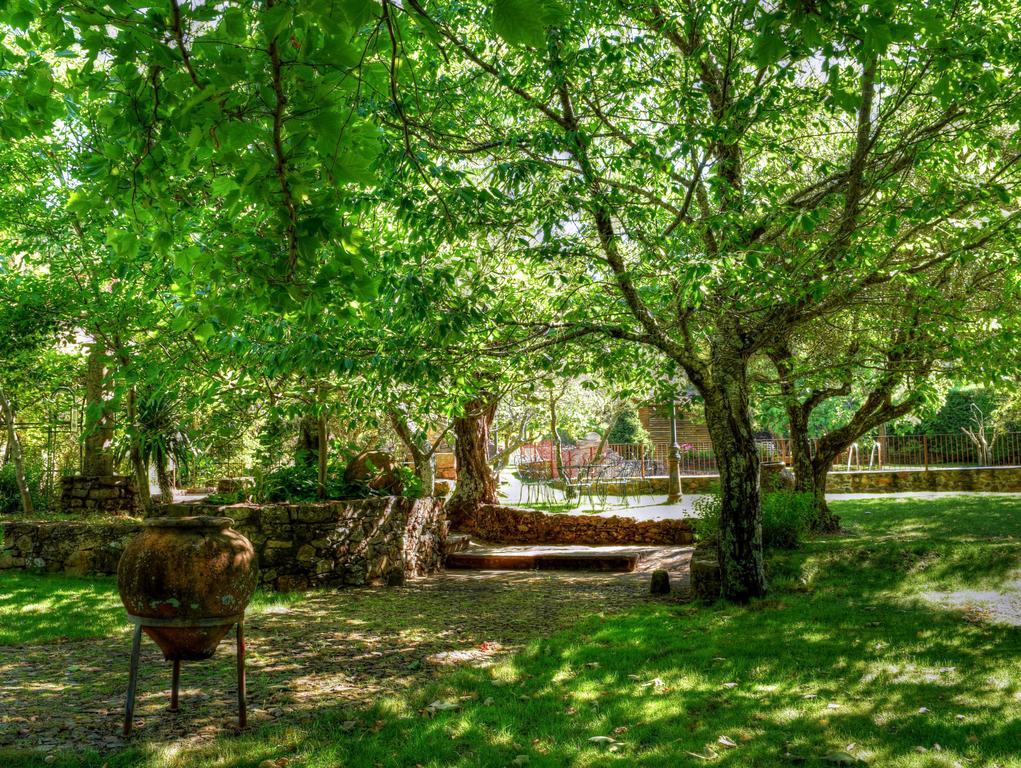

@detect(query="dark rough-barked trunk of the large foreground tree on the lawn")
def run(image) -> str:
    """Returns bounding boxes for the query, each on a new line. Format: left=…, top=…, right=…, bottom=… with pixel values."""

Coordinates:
left=702, top=353, right=767, bottom=602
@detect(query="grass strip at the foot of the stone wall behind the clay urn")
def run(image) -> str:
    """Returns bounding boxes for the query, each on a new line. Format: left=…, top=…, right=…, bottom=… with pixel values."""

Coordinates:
left=0, top=571, right=300, bottom=649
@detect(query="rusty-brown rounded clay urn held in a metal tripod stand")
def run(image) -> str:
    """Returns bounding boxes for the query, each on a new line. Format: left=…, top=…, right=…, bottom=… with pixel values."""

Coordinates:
left=117, top=517, right=258, bottom=661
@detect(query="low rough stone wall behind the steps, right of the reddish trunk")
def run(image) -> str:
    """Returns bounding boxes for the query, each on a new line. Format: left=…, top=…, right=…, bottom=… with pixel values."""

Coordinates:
left=463, top=505, right=693, bottom=545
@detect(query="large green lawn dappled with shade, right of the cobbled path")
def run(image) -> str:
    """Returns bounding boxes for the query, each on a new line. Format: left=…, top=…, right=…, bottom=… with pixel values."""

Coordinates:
left=0, top=496, right=1021, bottom=768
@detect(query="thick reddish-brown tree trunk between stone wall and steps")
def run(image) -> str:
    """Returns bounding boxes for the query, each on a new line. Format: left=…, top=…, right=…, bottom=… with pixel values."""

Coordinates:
left=446, top=394, right=498, bottom=528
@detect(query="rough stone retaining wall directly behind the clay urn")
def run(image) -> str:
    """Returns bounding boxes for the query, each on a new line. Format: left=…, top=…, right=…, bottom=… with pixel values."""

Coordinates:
left=0, top=496, right=446, bottom=590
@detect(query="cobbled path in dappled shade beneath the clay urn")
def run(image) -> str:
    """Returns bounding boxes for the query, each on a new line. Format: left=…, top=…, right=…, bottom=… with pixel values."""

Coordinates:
left=0, top=556, right=686, bottom=752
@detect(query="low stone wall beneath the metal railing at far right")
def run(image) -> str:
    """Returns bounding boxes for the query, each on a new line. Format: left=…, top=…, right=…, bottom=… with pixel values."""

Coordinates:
left=826, top=467, right=1021, bottom=493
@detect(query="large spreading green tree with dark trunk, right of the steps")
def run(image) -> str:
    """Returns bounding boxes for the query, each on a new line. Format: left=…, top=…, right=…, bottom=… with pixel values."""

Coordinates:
left=384, top=0, right=1021, bottom=599
